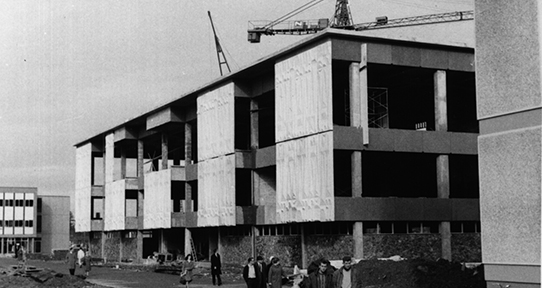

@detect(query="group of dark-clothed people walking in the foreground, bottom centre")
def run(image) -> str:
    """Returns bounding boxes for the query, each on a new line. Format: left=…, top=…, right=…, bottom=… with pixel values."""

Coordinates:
left=243, top=256, right=356, bottom=288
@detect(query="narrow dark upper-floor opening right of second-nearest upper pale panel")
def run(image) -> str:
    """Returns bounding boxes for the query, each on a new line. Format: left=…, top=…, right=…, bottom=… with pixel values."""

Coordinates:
left=234, top=97, right=251, bottom=150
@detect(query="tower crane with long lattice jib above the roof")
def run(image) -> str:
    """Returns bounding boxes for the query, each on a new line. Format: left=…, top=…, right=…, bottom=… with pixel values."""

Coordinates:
left=248, top=0, right=474, bottom=43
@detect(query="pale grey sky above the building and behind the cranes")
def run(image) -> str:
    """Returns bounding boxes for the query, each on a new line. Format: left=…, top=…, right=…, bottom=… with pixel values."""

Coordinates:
left=0, top=0, right=474, bottom=207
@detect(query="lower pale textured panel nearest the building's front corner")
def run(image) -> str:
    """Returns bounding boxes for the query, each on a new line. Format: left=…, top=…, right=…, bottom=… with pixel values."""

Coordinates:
left=276, top=132, right=335, bottom=223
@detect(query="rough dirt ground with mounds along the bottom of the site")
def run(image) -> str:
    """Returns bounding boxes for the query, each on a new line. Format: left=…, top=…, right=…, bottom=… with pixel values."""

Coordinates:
left=0, top=259, right=486, bottom=288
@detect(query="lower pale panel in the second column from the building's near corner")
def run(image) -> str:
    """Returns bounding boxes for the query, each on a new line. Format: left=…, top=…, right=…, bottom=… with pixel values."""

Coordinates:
left=198, top=154, right=235, bottom=227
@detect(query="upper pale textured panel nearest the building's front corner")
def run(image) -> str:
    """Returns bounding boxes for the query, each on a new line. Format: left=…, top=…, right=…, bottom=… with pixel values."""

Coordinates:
left=275, top=41, right=333, bottom=142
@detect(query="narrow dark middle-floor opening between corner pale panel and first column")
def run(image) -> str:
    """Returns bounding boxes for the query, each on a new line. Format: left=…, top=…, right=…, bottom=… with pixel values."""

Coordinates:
left=333, top=150, right=352, bottom=197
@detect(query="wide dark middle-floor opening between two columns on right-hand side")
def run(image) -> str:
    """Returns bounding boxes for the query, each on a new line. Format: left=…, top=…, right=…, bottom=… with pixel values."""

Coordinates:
left=361, top=151, right=437, bottom=198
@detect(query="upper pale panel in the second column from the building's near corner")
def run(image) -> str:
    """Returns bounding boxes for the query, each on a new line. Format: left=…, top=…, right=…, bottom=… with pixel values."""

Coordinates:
left=197, top=83, right=235, bottom=161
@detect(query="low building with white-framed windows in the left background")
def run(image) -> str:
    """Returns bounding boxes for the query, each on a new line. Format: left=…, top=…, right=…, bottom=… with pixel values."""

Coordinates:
left=0, top=187, right=70, bottom=255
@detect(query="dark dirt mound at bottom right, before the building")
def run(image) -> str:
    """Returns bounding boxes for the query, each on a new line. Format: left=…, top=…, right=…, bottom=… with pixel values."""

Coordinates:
left=354, top=259, right=486, bottom=288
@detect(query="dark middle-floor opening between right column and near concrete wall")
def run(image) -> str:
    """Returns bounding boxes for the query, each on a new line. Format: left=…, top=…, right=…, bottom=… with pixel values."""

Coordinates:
left=449, top=155, right=480, bottom=199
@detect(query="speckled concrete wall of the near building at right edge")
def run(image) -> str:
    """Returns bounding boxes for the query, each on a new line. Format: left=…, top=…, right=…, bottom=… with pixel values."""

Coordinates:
left=475, top=0, right=542, bottom=288
